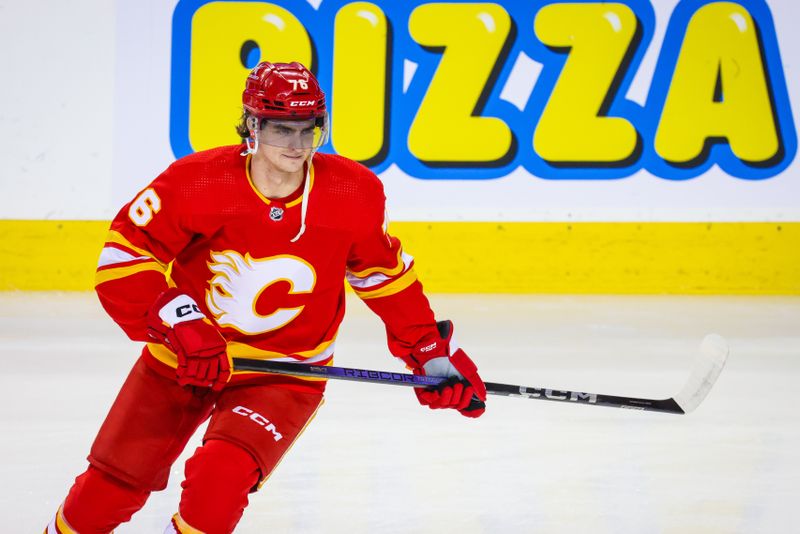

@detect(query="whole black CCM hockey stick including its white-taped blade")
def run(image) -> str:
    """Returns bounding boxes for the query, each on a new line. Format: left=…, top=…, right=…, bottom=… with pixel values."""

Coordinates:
left=228, top=334, right=728, bottom=414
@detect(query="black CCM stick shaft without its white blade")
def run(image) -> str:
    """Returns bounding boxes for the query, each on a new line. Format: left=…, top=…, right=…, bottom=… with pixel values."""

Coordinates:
left=233, top=358, right=685, bottom=414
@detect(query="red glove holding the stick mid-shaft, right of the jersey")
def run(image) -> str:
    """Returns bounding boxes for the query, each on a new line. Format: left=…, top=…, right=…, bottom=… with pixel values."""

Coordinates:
left=403, top=321, right=486, bottom=417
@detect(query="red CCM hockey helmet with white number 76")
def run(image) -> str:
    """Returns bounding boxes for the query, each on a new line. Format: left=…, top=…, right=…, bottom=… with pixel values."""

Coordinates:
left=242, top=61, right=326, bottom=121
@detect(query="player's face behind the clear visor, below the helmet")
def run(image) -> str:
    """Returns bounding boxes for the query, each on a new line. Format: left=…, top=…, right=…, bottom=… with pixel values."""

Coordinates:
left=258, top=119, right=319, bottom=172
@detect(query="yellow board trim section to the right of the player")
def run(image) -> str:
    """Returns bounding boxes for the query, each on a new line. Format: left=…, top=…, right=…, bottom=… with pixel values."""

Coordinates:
left=392, top=222, right=800, bottom=295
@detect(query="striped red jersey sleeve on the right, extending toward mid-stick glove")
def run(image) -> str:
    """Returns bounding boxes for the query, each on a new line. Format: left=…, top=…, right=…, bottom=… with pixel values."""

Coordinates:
left=346, top=183, right=438, bottom=357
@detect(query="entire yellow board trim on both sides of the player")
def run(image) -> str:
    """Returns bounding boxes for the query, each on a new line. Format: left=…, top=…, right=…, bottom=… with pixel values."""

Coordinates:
left=0, top=220, right=800, bottom=295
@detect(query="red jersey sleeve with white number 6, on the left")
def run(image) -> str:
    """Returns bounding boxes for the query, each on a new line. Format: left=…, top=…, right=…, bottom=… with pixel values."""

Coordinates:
left=95, top=169, right=198, bottom=341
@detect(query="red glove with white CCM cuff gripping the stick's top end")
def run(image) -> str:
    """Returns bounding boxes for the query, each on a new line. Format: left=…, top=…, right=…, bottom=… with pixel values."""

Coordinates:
left=147, top=288, right=231, bottom=391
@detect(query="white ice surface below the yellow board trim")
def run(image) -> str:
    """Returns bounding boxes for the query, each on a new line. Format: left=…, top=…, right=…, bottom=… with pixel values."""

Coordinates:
left=0, top=293, right=800, bottom=534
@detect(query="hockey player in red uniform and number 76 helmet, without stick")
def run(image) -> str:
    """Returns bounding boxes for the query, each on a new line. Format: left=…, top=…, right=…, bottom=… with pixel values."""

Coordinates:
left=46, top=62, right=486, bottom=534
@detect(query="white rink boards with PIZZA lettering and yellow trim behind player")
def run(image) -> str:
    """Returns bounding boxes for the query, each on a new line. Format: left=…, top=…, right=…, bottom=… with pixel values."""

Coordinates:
left=0, top=0, right=800, bottom=294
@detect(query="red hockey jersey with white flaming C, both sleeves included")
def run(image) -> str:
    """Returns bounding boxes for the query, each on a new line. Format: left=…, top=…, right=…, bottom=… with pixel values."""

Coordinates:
left=96, top=145, right=444, bottom=387
